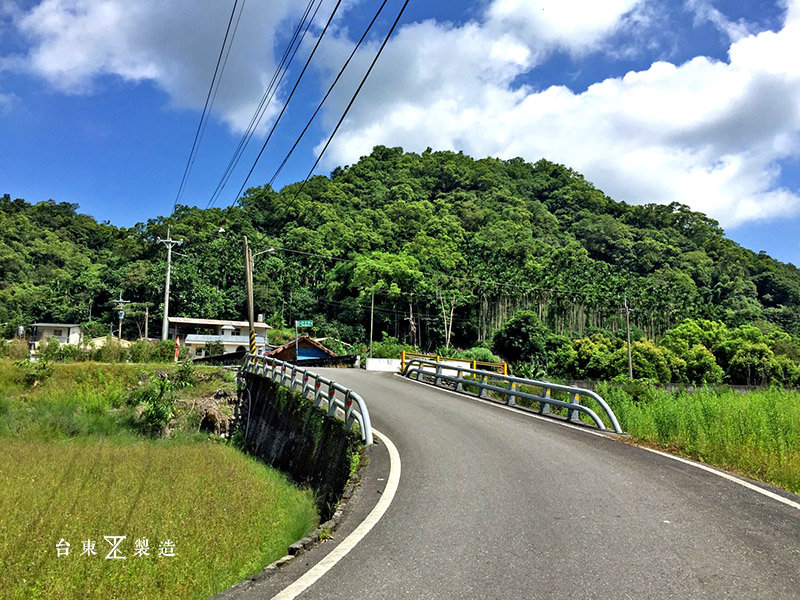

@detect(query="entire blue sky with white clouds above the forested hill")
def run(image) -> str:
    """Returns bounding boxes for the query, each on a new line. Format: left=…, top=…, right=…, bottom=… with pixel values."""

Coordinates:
left=0, top=0, right=800, bottom=264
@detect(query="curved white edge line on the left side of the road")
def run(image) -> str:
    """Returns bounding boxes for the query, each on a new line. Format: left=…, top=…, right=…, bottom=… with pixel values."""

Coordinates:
left=272, top=429, right=401, bottom=600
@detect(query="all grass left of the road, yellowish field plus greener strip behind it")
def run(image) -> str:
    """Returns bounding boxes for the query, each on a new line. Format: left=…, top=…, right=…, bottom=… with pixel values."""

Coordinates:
left=0, top=361, right=317, bottom=598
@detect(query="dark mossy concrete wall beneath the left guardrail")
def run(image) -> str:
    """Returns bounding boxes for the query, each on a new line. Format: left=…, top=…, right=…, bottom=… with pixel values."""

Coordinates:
left=234, top=373, right=361, bottom=520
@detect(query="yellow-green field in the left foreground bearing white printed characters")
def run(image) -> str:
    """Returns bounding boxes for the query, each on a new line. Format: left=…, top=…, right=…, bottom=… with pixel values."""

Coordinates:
left=0, top=439, right=316, bottom=599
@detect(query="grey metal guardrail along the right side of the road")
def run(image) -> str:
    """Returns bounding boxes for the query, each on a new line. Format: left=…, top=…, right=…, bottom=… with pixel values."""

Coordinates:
left=402, top=358, right=622, bottom=433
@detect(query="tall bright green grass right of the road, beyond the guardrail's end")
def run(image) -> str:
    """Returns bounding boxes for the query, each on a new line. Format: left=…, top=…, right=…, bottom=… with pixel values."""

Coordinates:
left=597, top=384, right=800, bottom=493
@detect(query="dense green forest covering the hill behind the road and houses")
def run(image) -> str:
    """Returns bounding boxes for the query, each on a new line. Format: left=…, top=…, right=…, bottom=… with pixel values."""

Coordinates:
left=0, top=146, right=800, bottom=385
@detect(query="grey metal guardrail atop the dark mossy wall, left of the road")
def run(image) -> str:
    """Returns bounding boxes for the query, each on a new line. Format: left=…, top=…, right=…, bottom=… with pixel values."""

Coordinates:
left=242, top=354, right=372, bottom=446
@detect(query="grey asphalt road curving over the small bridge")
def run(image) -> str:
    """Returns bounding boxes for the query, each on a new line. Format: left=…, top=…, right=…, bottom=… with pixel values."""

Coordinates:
left=225, top=369, right=800, bottom=600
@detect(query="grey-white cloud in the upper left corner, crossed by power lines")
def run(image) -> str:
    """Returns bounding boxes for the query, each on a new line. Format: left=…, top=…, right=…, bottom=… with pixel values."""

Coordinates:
left=5, top=0, right=299, bottom=129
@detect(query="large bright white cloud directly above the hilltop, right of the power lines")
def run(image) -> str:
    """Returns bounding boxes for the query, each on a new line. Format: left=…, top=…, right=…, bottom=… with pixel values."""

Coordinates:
left=318, top=0, right=800, bottom=227
